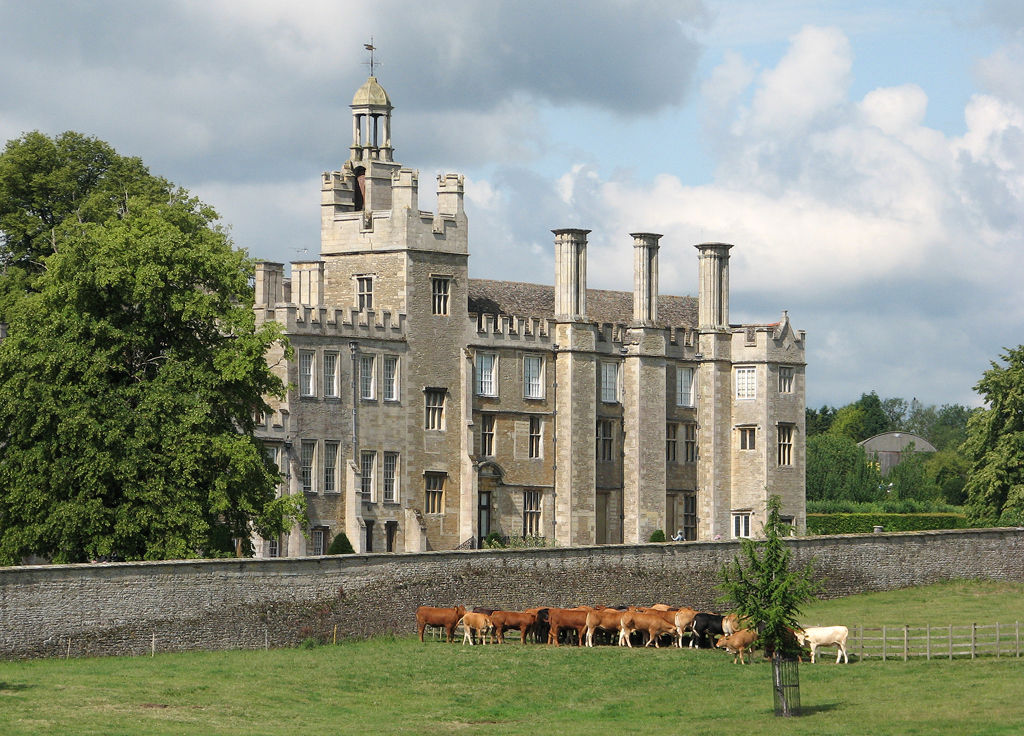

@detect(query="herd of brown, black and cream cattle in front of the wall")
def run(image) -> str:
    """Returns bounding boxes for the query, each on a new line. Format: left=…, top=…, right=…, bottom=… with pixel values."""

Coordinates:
left=416, top=604, right=849, bottom=664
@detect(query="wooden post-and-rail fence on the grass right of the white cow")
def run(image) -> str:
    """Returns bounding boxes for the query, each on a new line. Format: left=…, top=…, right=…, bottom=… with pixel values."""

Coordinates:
left=843, top=621, right=1021, bottom=661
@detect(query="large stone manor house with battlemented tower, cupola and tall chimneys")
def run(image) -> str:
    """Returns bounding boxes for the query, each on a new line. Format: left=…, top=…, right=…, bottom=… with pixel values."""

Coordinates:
left=254, top=76, right=806, bottom=557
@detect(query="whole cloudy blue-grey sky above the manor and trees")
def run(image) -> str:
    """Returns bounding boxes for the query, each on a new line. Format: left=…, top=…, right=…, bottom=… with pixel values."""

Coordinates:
left=0, top=0, right=1024, bottom=407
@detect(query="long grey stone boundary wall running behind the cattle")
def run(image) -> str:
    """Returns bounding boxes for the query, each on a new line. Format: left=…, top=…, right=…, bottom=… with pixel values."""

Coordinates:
left=0, top=528, right=1024, bottom=659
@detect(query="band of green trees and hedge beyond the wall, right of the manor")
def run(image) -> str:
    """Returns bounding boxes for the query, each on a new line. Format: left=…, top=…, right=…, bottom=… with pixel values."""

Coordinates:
left=807, top=345, right=1024, bottom=526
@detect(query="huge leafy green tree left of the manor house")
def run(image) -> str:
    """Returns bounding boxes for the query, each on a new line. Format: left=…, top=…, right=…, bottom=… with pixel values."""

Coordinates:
left=0, top=133, right=301, bottom=564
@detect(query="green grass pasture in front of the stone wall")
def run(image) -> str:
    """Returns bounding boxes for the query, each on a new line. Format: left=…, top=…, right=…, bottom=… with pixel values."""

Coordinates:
left=0, top=582, right=1024, bottom=736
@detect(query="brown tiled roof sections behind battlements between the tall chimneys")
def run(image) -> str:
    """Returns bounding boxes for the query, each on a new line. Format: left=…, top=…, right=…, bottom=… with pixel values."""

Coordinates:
left=469, top=278, right=697, bottom=328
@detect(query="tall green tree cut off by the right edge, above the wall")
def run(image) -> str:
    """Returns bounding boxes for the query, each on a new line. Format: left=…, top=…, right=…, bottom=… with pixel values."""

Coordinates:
left=964, top=345, right=1024, bottom=526
